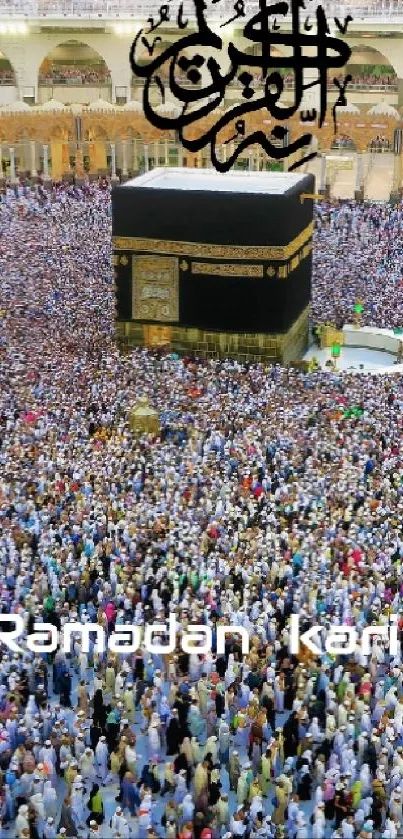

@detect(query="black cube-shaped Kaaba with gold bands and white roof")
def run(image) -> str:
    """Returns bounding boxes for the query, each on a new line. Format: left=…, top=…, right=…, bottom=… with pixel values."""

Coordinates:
left=112, top=168, right=314, bottom=362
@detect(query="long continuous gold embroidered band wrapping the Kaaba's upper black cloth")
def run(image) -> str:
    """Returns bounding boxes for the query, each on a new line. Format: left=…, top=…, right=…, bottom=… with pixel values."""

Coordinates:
left=112, top=223, right=313, bottom=261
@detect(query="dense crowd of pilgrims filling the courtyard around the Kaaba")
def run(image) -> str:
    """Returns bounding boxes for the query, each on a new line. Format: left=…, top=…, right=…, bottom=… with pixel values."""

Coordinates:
left=0, top=183, right=403, bottom=839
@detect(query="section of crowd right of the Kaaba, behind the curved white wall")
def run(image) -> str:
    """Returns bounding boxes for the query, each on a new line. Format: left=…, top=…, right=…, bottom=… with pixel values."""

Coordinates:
left=312, top=201, right=403, bottom=329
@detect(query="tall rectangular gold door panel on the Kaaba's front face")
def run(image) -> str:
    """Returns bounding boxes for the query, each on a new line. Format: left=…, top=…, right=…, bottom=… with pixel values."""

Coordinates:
left=132, top=256, right=179, bottom=323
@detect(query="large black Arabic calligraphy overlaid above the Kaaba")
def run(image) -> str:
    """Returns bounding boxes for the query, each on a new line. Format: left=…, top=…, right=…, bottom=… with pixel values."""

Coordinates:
left=130, top=0, right=352, bottom=172
